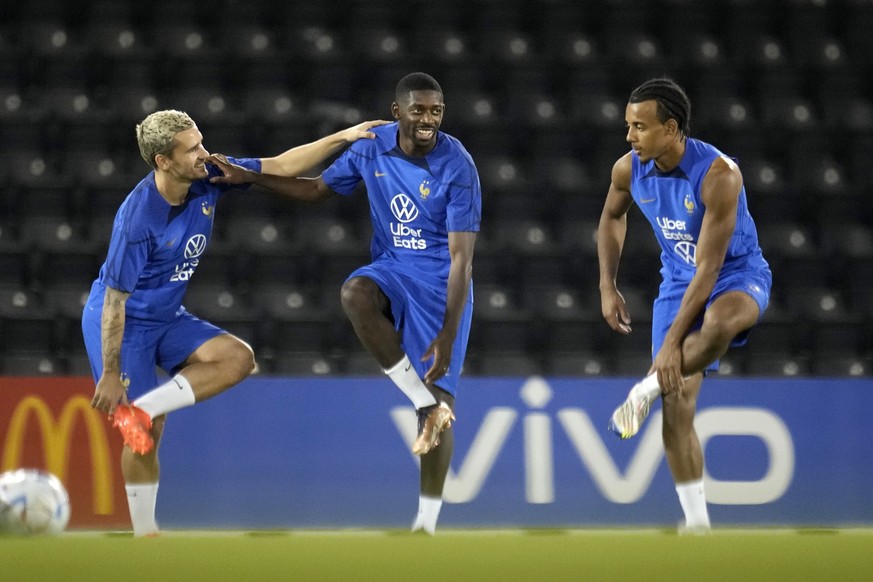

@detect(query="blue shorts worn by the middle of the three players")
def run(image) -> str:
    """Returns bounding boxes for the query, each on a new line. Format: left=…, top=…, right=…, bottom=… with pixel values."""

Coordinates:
left=348, top=261, right=473, bottom=396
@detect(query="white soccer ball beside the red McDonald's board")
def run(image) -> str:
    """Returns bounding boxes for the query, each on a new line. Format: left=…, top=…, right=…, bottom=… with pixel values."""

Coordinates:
left=0, top=469, right=70, bottom=535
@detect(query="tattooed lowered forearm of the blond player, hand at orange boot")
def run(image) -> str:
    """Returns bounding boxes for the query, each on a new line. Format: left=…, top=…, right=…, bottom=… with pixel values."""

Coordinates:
left=91, top=287, right=130, bottom=414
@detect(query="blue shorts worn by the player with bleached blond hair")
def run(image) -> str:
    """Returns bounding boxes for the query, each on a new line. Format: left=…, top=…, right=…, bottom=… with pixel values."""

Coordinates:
left=82, top=294, right=227, bottom=401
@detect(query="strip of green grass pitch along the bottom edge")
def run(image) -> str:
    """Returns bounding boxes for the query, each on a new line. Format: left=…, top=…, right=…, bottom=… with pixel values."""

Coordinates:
left=0, top=528, right=873, bottom=582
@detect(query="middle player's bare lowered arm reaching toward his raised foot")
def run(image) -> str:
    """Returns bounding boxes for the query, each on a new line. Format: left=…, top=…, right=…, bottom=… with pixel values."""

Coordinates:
left=421, top=232, right=476, bottom=384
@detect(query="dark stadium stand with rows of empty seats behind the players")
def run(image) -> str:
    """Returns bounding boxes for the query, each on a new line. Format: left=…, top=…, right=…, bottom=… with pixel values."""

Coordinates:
left=0, top=0, right=873, bottom=376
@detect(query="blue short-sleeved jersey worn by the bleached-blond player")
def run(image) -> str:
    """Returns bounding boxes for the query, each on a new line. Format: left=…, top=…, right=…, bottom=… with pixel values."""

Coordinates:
left=89, top=158, right=261, bottom=323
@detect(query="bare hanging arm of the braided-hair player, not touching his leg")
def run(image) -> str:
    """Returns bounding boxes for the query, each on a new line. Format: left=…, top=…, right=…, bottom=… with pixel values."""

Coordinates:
left=597, top=153, right=633, bottom=334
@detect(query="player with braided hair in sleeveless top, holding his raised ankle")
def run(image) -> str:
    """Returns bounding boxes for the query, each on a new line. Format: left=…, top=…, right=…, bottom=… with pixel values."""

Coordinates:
left=597, top=78, right=773, bottom=533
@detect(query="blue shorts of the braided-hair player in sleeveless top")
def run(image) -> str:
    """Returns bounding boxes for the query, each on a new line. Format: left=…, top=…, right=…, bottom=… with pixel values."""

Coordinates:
left=652, top=270, right=773, bottom=372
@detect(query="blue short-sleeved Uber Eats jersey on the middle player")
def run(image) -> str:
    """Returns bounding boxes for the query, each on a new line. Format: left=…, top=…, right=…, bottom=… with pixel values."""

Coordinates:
left=322, top=122, right=482, bottom=280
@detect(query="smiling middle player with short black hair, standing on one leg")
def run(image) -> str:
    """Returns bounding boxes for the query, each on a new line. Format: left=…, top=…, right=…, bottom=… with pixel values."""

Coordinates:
left=210, top=73, right=482, bottom=534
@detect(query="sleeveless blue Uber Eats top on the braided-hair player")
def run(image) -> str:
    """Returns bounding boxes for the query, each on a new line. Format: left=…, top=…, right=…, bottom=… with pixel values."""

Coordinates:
left=631, top=138, right=769, bottom=284
